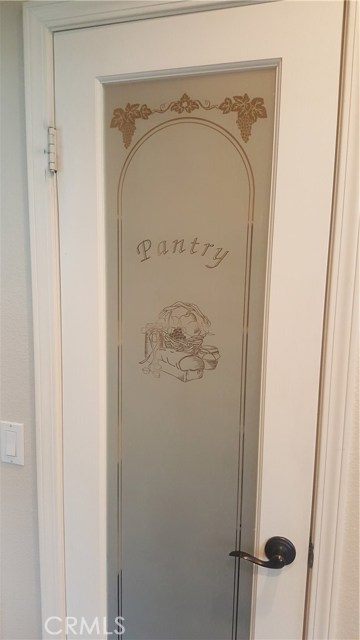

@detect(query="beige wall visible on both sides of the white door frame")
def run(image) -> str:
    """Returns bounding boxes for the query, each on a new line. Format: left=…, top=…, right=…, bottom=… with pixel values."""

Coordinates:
left=0, top=2, right=360, bottom=640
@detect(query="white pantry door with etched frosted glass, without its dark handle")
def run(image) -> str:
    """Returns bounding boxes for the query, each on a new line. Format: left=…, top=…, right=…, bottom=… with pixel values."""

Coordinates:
left=54, top=2, right=343, bottom=640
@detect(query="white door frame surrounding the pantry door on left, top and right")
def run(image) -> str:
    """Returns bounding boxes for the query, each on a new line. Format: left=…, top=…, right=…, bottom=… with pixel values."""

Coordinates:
left=24, top=0, right=359, bottom=639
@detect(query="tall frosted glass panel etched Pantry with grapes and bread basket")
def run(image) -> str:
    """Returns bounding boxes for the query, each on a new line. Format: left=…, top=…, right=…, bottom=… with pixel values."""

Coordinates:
left=104, top=68, right=276, bottom=640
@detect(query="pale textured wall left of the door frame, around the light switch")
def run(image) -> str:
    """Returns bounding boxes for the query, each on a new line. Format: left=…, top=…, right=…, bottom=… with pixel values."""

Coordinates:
left=0, top=2, right=41, bottom=640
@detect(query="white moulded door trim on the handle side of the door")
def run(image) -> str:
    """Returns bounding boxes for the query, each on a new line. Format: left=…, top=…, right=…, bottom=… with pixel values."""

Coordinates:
left=304, top=0, right=359, bottom=640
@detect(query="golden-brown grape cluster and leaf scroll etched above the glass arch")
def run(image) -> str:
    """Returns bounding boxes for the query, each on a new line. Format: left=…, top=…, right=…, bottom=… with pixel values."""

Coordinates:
left=110, top=93, right=267, bottom=149
